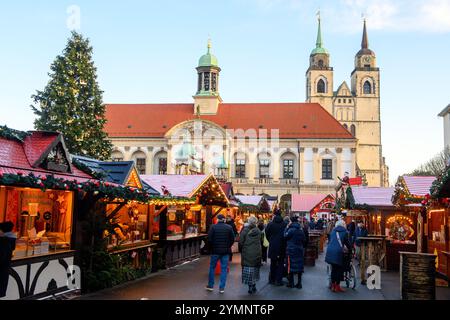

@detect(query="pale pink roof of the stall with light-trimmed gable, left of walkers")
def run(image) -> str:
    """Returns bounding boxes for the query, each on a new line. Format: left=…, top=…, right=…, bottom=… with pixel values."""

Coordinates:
left=141, top=175, right=210, bottom=198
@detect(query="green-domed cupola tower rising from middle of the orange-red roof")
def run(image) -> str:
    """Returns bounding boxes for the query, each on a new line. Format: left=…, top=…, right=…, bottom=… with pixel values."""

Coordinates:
left=194, top=40, right=222, bottom=115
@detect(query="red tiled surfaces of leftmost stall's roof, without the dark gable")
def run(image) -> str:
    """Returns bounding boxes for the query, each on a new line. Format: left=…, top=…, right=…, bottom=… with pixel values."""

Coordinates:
left=0, top=132, right=92, bottom=181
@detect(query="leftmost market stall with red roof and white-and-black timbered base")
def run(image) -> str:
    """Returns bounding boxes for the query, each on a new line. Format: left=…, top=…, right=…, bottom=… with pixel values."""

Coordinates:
left=0, top=127, right=98, bottom=300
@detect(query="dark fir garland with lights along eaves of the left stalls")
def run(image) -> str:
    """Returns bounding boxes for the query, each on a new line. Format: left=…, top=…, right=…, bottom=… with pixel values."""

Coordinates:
left=0, top=172, right=195, bottom=203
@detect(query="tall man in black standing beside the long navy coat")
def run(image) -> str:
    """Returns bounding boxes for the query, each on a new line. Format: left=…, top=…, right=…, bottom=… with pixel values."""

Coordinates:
left=266, top=211, right=287, bottom=286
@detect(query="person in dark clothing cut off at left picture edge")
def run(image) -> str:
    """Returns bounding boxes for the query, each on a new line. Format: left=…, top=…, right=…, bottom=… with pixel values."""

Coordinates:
left=0, top=221, right=16, bottom=298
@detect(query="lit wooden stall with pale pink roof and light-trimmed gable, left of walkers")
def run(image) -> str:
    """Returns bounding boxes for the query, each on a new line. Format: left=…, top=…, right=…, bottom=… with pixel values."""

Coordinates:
left=141, top=174, right=229, bottom=268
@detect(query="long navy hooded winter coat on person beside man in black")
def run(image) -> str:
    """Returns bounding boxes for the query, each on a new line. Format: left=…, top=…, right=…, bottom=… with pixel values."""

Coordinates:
left=284, top=222, right=306, bottom=273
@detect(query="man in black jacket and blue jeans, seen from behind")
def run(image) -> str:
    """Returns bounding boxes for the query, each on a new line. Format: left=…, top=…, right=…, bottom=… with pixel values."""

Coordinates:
left=206, top=214, right=234, bottom=293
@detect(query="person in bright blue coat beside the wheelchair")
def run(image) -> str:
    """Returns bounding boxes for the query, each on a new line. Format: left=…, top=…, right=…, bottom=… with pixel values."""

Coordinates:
left=325, top=220, right=351, bottom=292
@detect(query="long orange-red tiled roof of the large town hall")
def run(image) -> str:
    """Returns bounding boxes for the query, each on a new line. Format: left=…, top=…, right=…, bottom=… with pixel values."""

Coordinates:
left=105, top=103, right=354, bottom=139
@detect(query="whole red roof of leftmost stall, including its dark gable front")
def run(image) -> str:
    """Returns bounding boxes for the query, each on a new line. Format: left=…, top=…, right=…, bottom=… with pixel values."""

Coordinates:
left=0, top=131, right=93, bottom=182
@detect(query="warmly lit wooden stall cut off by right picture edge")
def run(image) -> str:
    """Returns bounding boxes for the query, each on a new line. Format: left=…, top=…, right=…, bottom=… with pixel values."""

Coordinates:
left=424, top=167, right=450, bottom=286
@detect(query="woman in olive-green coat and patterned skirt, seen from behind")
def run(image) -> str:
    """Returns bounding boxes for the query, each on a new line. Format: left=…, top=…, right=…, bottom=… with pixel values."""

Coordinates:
left=239, top=216, right=262, bottom=294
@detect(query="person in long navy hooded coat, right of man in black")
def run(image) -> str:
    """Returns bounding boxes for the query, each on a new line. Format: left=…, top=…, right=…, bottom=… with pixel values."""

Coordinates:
left=284, top=216, right=306, bottom=289
